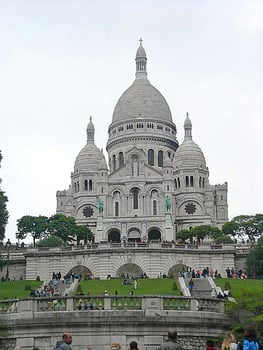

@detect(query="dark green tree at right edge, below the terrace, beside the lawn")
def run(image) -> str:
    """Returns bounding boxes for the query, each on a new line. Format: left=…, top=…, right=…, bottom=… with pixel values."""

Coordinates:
left=246, top=237, right=263, bottom=278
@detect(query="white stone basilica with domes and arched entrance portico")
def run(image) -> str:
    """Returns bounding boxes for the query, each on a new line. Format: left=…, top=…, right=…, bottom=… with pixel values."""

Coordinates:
left=57, top=41, right=228, bottom=242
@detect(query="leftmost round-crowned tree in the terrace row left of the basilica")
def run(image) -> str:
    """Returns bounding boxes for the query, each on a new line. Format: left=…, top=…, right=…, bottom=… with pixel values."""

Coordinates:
left=16, top=215, right=48, bottom=247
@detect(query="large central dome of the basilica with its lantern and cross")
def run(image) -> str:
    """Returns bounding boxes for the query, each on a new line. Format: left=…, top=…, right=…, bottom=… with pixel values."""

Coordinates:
left=112, top=39, right=172, bottom=123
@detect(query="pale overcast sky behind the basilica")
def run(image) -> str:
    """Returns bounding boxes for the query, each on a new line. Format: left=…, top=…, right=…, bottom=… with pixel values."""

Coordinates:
left=0, top=0, right=263, bottom=242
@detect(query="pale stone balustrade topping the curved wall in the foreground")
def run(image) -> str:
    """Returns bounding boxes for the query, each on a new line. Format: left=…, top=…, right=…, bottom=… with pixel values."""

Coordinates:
left=0, top=295, right=227, bottom=315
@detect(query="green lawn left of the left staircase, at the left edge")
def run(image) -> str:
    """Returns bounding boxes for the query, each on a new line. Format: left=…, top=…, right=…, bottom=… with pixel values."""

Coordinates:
left=0, top=280, right=42, bottom=300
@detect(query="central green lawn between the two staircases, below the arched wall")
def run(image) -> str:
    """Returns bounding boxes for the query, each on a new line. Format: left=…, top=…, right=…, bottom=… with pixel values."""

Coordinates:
left=80, top=278, right=180, bottom=295
